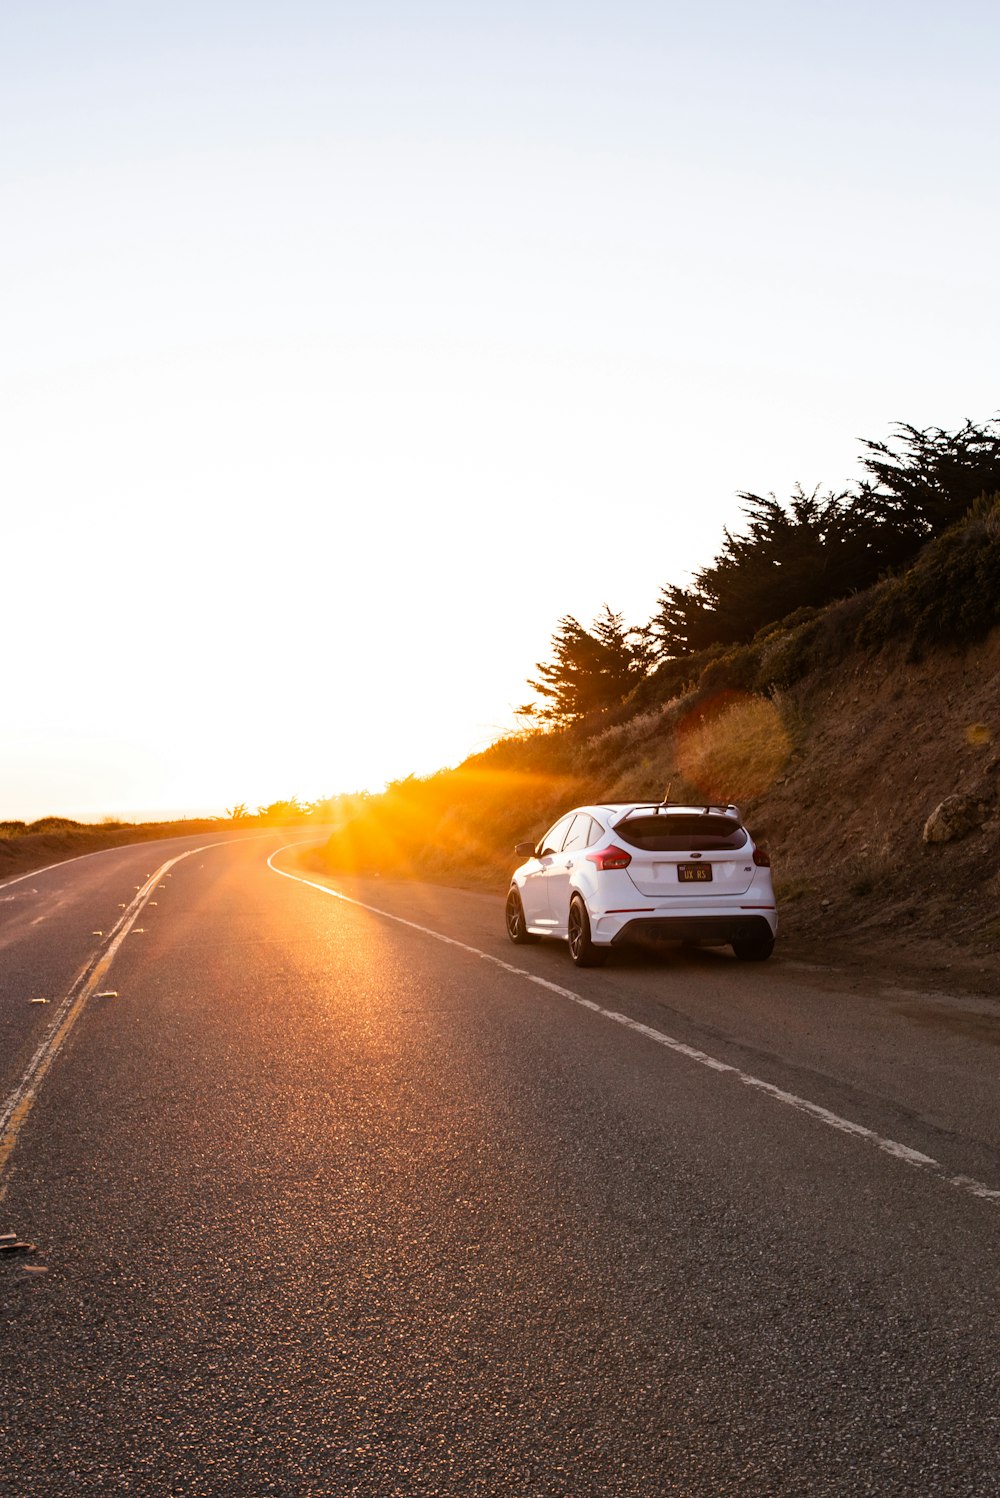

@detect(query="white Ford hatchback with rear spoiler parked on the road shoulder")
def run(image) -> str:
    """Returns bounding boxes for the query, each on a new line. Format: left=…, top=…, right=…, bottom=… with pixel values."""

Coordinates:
left=506, top=801, right=778, bottom=968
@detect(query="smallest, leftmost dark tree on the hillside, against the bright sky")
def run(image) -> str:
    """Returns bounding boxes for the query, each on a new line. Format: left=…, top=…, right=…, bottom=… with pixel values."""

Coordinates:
left=528, top=604, right=651, bottom=724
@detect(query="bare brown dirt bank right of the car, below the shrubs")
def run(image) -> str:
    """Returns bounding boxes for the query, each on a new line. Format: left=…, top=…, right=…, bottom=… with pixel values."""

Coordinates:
left=750, top=631, right=1000, bottom=992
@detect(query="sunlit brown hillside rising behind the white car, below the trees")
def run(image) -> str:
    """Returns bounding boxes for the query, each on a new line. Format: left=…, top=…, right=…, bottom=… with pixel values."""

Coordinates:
left=316, top=502, right=1000, bottom=987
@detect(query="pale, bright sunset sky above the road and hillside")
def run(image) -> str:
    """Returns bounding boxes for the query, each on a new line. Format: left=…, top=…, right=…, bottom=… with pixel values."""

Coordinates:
left=0, top=0, right=1000, bottom=819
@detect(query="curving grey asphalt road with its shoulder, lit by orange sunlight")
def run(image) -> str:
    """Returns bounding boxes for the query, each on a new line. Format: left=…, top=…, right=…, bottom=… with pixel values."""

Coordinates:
left=0, top=837, right=1000, bottom=1498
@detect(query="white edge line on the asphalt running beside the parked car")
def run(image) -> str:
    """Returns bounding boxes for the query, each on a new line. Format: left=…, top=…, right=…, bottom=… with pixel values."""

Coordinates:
left=268, top=843, right=1000, bottom=1201
